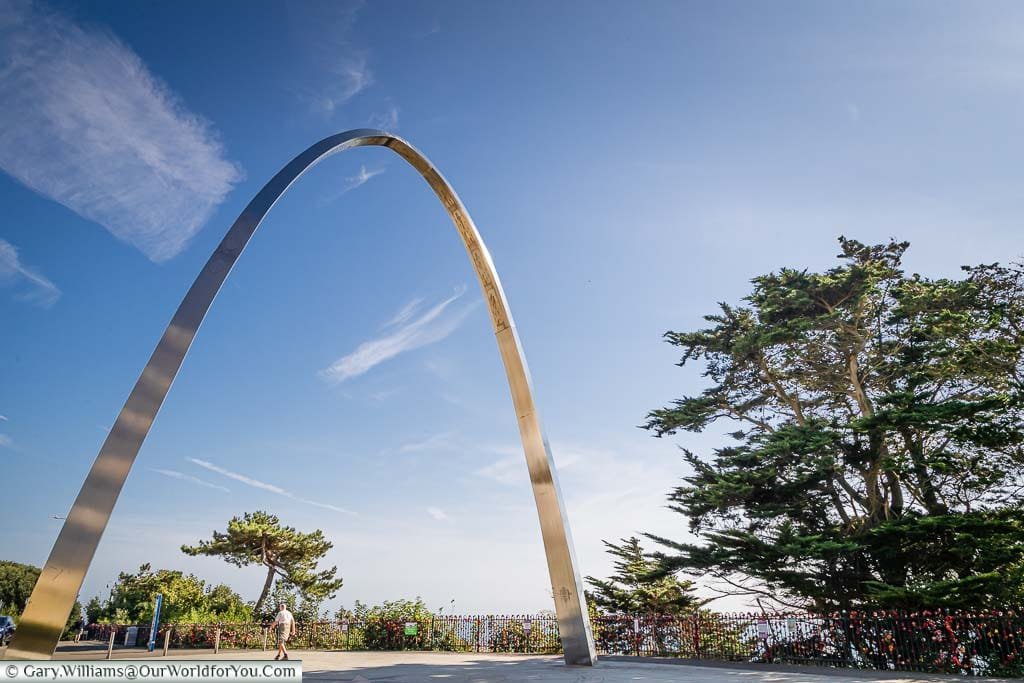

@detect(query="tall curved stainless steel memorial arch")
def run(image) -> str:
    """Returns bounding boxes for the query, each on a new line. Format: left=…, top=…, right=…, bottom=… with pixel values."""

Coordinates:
left=5, top=129, right=597, bottom=665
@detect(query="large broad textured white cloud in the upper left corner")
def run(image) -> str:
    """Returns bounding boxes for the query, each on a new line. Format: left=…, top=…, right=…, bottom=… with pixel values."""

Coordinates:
left=0, top=0, right=242, bottom=261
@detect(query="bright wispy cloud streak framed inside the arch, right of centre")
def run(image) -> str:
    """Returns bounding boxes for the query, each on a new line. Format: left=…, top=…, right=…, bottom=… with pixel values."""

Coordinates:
left=321, top=290, right=473, bottom=382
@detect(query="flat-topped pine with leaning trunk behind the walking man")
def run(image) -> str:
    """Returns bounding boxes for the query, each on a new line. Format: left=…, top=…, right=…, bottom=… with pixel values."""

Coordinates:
left=181, top=510, right=342, bottom=613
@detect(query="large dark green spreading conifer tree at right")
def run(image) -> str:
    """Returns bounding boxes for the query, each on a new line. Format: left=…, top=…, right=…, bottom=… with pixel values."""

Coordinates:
left=644, top=238, right=1024, bottom=609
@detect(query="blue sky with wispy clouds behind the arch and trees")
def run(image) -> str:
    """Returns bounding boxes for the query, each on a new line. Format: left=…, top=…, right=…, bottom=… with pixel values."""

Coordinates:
left=0, top=0, right=1024, bottom=612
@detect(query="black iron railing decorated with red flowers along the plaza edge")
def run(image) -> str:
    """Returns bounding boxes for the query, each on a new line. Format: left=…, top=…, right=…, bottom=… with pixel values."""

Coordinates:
left=84, top=611, right=1024, bottom=676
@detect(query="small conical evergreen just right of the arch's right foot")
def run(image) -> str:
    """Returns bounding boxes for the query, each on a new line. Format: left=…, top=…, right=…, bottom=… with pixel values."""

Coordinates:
left=587, top=537, right=702, bottom=615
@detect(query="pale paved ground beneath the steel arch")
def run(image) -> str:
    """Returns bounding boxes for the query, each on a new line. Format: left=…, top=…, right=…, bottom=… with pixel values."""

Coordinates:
left=6, top=646, right=1008, bottom=683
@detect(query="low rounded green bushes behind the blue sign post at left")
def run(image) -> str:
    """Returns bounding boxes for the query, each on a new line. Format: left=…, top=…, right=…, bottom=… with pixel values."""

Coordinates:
left=86, top=564, right=252, bottom=624
